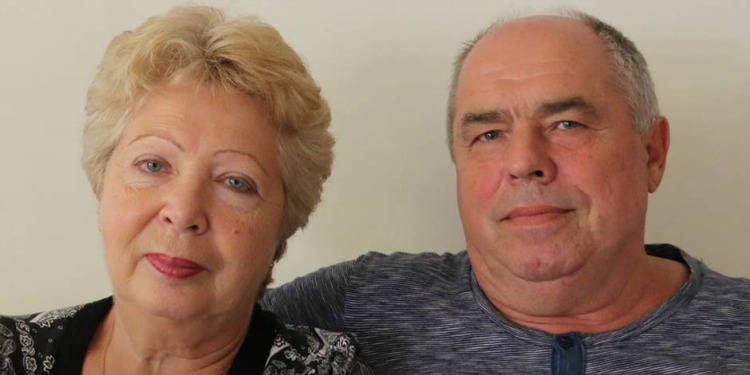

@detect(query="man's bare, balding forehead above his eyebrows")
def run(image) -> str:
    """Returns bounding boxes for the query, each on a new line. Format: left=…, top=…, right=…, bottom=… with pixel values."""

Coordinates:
left=456, top=16, right=612, bottom=101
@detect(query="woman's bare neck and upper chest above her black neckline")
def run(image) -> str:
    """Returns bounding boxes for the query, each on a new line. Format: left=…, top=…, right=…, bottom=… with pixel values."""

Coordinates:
left=83, top=303, right=252, bottom=375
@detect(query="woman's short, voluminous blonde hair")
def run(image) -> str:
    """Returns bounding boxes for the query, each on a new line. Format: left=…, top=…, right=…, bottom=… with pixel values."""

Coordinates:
left=82, top=6, right=334, bottom=259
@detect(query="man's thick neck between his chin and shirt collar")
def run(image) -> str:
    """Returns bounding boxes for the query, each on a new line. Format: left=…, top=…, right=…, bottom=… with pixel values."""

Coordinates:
left=472, top=253, right=689, bottom=334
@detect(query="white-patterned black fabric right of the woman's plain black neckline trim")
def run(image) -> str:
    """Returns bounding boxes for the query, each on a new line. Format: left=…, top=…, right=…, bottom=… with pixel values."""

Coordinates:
left=264, top=321, right=372, bottom=375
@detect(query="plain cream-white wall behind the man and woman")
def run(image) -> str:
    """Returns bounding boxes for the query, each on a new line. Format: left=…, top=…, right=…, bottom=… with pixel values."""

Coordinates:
left=0, top=0, right=750, bottom=314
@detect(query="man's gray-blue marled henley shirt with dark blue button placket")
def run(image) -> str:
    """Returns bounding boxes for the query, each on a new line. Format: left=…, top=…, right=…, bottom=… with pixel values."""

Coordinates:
left=262, top=245, right=750, bottom=375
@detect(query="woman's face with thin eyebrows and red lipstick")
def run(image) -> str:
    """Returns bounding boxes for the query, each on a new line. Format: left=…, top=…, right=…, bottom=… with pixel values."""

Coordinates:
left=100, top=84, right=284, bottom=320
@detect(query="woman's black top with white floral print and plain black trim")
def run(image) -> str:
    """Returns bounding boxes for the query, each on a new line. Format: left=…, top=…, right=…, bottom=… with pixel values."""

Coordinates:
left=0, top=298, right=372, bottom=375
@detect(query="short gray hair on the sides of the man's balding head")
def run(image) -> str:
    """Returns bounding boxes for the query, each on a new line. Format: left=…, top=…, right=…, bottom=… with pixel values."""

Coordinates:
left=447, top=9, right=660, bottom=155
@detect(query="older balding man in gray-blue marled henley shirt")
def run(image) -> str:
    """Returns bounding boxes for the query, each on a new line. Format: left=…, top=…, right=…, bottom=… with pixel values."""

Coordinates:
left=265, top=12, right=750, bottom=374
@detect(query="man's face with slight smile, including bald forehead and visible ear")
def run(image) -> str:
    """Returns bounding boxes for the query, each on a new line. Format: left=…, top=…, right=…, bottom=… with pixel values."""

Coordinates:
left=452, top=17, right=668, bottom=281
